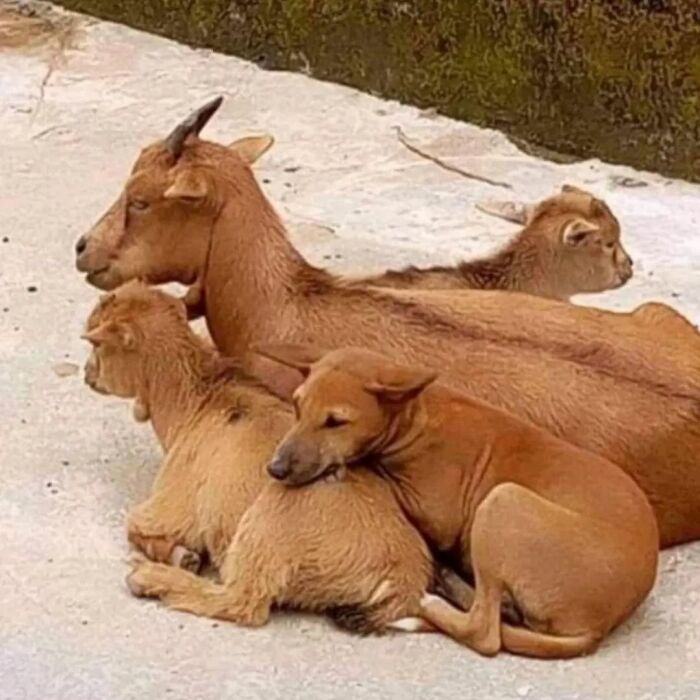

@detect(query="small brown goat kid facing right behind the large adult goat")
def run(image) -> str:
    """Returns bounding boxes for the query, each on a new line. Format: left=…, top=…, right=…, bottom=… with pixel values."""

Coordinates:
left=360, top=186, right=632, bottom=301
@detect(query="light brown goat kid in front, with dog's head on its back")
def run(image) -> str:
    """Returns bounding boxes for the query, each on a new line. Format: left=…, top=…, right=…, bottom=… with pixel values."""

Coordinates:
left=86, top=283, right=432, bottom=633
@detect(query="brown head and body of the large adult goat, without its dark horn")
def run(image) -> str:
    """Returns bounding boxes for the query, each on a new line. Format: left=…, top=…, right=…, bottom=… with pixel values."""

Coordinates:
left=78, top=100, right=700, bottom=546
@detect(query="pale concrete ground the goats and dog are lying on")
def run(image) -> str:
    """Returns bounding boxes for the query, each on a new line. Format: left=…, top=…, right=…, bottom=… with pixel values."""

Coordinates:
left=0, top=2, right=700, bottom=700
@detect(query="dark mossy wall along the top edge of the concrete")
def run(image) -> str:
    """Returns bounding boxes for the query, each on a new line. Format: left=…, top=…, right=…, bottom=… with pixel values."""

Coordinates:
left=60, top=0, right=700, bottom=181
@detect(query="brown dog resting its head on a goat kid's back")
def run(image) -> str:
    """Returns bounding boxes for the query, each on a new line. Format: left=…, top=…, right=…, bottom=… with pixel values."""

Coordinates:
left=260, top=345, right=659, bottom=658
